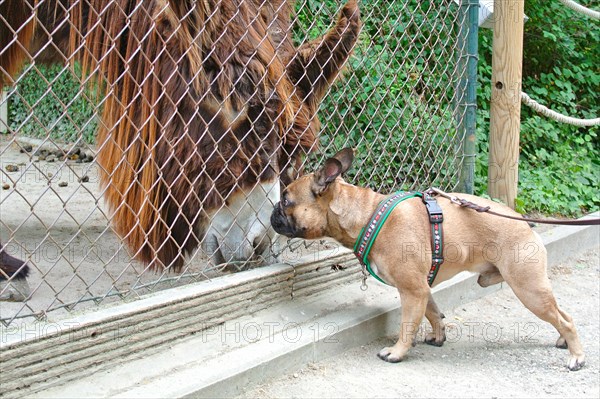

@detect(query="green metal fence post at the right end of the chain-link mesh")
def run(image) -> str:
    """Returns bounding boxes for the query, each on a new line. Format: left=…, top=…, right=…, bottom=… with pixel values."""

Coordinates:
left=456, top=0, right=479, bottom=194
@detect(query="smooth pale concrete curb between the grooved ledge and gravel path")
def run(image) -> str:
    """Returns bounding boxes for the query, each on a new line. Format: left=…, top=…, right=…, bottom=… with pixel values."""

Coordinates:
left=34, top=217, right=600, bottom=398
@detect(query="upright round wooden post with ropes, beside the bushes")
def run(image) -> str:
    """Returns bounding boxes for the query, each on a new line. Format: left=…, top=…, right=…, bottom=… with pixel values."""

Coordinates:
left=488, top=0, right=525, bottom=209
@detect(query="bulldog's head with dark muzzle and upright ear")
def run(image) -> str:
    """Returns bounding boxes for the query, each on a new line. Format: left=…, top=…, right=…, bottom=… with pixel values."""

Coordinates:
left=271, top=148, right=354, bottom=239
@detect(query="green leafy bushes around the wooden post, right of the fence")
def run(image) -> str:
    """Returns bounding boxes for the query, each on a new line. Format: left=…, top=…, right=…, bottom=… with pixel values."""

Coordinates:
left=475, top=0, right=600, bottom=216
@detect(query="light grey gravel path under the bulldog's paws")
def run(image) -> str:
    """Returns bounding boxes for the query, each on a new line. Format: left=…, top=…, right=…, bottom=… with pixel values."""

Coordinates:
left=241, top=249, right=600, bottom=398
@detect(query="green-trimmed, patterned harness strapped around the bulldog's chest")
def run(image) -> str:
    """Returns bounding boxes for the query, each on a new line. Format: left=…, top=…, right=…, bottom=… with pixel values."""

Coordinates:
left=354, top=191, right=444, bottom=289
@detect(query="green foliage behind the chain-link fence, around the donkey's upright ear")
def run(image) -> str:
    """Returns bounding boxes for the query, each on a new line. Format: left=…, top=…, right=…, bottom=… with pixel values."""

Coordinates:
left=295, top=0, right=457, bottom=191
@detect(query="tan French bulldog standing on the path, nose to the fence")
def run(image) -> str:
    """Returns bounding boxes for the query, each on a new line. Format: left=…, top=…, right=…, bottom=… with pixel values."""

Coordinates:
left=271, top=148, right=585, bottom=371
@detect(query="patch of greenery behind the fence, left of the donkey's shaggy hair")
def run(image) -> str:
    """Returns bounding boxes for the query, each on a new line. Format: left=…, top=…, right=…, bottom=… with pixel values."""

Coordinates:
left=9, top=65, right=97, bottom=143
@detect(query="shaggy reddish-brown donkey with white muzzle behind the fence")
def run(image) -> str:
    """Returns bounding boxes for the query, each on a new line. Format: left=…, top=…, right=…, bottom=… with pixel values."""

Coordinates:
left=0, top=0, right=361, bottom=280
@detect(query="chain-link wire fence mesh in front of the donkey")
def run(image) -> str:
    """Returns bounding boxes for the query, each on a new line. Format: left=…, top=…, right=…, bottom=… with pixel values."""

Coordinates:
left=0, top=0, right=473, bottom=327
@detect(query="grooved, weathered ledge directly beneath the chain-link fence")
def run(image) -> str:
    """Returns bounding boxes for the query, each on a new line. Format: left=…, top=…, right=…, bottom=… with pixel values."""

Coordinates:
left=0, top=248, right=359, bottom=397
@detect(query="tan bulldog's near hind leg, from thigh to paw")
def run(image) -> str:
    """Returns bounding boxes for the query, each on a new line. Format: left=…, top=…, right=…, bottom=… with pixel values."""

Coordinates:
left=504, top=249, right=585, bottom=371
